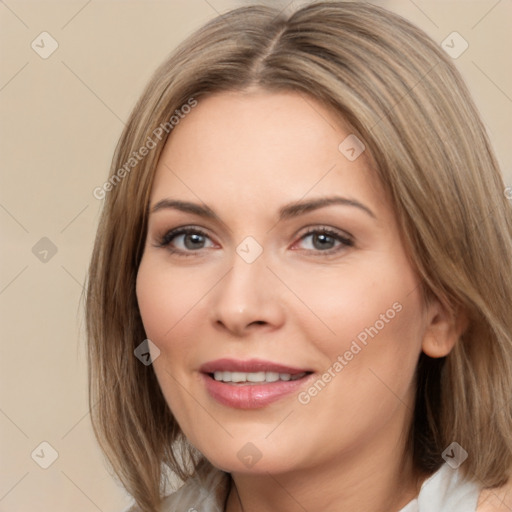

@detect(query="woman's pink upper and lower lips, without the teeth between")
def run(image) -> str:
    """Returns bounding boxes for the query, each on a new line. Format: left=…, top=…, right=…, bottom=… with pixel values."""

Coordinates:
left=201, top=359, right=312, bottom=409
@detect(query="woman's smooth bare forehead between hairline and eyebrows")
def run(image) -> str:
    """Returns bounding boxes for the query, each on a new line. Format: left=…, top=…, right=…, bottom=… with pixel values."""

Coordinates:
left=152, top=90, right=385, bottom=219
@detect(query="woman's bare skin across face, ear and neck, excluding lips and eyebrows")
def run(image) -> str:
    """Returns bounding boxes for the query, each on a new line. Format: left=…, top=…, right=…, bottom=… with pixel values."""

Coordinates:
left=137, top=89, right=468, bottom=512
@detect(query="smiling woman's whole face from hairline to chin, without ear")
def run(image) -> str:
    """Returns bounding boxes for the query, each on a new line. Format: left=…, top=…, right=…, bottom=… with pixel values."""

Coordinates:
left=137, top=90, right=438, bottom=473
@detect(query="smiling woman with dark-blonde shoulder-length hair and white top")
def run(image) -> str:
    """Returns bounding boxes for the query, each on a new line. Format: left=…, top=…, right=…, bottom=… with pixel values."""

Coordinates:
left=87, top=2, right=512, bottom=512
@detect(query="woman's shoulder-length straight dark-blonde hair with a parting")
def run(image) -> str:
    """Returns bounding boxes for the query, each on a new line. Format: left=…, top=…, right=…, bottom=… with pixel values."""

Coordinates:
left=86, top=2, right=512, bottom=512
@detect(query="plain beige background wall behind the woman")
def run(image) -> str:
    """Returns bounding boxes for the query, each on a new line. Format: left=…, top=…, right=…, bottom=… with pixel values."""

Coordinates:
left=0, top=0, right=512, bottom=512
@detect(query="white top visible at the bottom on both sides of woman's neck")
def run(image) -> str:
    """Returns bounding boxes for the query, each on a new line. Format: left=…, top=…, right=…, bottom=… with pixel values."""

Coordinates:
left=124, top=463, right=481, bottom=512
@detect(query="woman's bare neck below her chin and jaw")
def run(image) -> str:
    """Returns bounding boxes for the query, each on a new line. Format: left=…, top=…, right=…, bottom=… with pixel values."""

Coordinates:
left=226, top=432, right=428, bottom=512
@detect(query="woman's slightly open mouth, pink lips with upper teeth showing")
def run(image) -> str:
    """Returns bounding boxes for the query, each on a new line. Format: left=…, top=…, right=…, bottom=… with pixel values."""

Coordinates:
left=200, top=359, right=313, bottom=409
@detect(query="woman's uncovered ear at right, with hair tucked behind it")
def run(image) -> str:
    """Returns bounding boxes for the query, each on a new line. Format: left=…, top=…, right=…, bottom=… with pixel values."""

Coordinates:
left=421, top=298, right=468, bottom=358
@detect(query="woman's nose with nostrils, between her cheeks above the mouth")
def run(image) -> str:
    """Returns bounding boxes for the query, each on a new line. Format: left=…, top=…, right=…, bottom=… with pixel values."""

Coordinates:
left=210, top=250, right=285, bottom=337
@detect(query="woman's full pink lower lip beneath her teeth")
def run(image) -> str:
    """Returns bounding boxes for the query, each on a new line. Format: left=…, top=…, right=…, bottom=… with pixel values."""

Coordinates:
left=201, top=373, right=313, bottom=409
